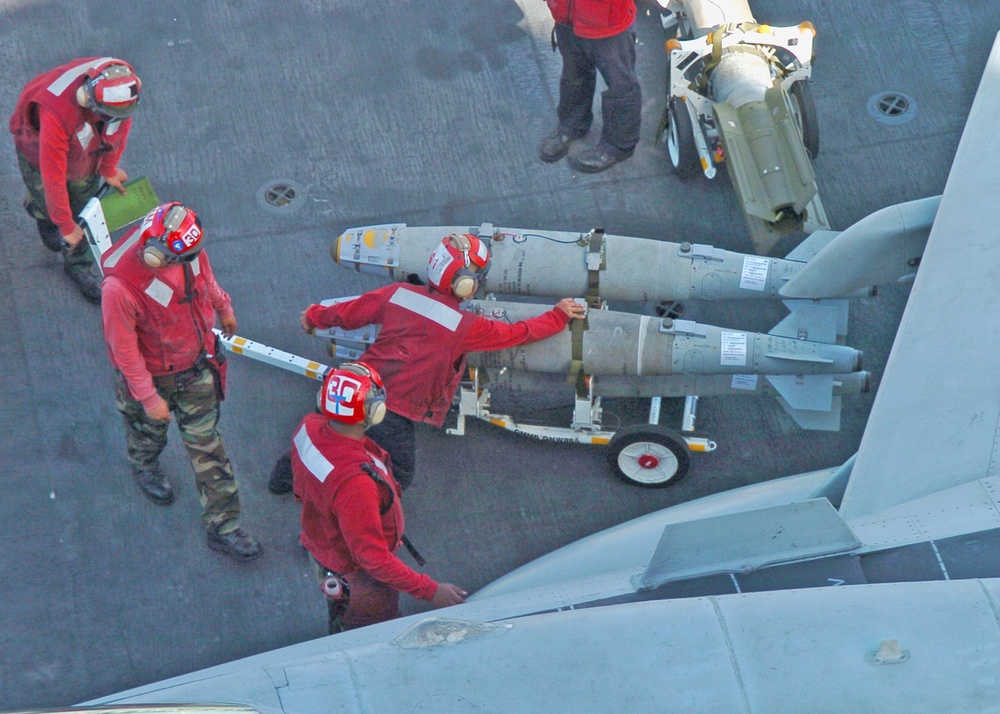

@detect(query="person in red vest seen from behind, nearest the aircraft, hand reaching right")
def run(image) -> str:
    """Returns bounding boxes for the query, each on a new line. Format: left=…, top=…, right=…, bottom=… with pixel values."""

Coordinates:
left=292, top=362, right=467, bottom=634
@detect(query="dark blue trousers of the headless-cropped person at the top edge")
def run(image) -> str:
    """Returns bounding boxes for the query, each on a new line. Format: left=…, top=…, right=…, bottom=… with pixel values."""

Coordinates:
left=556, top=23, right=642, bottom=159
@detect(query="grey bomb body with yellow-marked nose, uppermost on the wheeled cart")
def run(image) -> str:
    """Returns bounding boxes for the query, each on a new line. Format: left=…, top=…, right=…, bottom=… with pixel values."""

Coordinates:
left=331, top=224, right=812, bottom=302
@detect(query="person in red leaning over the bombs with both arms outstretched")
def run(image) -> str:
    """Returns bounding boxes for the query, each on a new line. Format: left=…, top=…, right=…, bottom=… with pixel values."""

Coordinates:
left=268, top=234, right=584, bottom=493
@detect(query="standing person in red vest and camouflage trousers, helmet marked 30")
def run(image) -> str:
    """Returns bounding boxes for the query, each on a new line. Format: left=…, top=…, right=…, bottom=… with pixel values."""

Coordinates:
left=101, top=203, right=261, bottom=560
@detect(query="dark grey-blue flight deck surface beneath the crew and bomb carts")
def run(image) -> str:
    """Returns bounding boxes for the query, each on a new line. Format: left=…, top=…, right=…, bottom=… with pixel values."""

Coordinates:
left=0, top=0, right=1000, bottom=710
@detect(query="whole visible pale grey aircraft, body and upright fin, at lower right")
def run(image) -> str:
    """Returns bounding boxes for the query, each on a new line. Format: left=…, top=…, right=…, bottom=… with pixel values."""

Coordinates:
left=80, top=30, right=1000, bottom=714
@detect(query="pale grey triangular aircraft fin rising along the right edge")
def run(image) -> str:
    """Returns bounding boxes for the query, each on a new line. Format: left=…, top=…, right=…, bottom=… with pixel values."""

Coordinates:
left=841, top=32, right=1000, bottom=520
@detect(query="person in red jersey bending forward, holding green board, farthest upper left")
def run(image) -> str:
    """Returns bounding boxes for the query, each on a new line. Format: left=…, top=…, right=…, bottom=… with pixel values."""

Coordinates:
left=10, top=57, right=142, bottom=303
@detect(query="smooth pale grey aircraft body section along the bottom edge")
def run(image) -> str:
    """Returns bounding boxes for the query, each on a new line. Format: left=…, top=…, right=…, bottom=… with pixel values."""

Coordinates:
left=90, top=579, right=1000, bottom=714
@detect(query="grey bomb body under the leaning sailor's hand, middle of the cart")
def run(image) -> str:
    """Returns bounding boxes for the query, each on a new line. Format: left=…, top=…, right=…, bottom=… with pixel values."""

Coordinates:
left=467, top=300, right=861, bottom=376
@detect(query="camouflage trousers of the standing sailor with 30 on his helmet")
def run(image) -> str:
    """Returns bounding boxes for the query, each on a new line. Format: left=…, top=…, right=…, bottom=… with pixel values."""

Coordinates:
left=115, top=365, right=240, bottom=533
